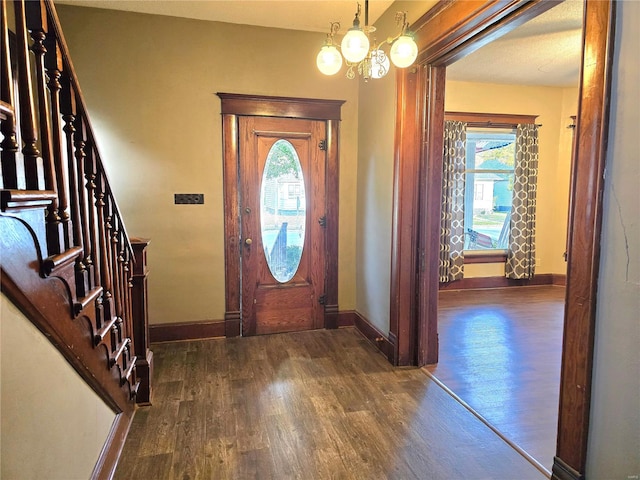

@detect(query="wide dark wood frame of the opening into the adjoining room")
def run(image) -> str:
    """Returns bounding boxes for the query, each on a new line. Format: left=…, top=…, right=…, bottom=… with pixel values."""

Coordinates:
left=390, top=0, right=615, bottom=480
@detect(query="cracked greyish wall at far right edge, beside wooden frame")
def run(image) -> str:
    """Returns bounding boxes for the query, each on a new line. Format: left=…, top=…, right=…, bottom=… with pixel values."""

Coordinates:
left=586, top=2, right=640, bottom=479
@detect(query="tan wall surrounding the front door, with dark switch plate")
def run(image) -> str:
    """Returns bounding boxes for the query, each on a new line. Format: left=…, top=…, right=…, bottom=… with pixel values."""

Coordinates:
left=59, top=6, right=358, bottom=324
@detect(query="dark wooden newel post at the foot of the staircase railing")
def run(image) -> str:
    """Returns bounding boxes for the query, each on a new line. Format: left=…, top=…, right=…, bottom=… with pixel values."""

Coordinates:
left=130, top=238, right=153, bottom=405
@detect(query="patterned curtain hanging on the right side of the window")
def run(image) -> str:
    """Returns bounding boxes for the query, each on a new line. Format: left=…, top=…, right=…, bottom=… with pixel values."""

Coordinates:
left=505, top=124, right=538, bottom=279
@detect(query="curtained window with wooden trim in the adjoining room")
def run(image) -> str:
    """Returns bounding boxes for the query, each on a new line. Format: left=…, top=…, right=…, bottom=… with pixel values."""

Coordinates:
left=440, top=112, right=539, bottom=270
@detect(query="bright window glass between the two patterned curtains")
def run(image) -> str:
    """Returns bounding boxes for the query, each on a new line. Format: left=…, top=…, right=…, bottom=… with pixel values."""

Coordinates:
left=464, top=128, right=516, bottom=250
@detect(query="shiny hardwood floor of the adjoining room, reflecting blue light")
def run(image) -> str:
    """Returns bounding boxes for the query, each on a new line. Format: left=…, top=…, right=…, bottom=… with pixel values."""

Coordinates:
left=427, top=286, right=565, bottom=471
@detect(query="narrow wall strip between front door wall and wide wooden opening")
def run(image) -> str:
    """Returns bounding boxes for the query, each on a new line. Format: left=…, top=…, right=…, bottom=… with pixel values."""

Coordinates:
left=356, top=1, right=436, bottom=334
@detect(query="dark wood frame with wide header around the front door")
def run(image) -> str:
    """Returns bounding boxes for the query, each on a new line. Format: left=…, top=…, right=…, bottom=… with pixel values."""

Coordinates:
left=217, top=93, right=344, bottom=337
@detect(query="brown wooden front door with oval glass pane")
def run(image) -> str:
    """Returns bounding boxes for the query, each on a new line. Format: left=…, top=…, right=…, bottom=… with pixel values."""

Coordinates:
left=238, top=116, right=326, bottom=335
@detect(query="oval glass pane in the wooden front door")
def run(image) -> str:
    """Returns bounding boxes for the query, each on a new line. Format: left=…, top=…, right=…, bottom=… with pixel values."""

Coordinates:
left=260, top=139, right=307, bottom=283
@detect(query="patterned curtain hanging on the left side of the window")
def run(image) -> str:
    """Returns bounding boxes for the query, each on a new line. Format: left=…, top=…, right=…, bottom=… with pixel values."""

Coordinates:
left=440, top=121, right=467, bottom=283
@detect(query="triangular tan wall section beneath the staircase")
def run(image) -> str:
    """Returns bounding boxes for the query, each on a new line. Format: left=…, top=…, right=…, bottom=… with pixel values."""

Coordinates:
left=0, top=294, right=115, bottom=480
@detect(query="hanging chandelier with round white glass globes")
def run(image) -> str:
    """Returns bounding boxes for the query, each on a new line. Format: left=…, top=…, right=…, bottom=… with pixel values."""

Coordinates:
left=316, top=0, right=418, bottom=81
